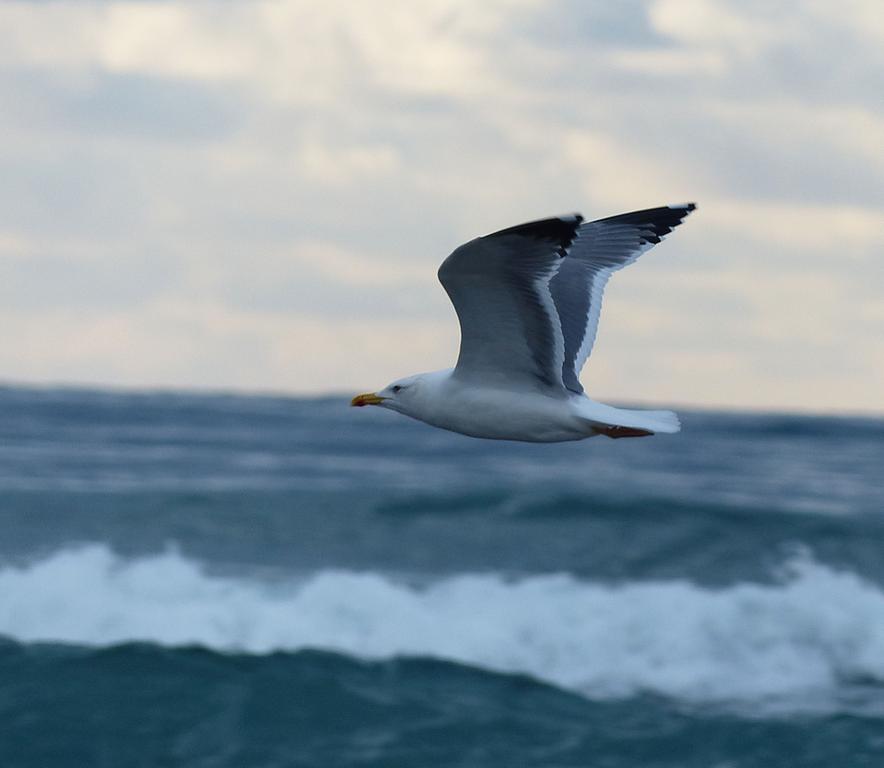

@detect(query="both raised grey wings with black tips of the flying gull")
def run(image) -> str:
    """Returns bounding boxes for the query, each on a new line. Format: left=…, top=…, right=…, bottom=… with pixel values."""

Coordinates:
left=439, top=204, right=694, bottom=397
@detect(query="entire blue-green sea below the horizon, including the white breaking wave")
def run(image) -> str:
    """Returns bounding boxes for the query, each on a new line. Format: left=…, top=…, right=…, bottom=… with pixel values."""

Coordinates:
left=0, top=387, right=884, bottom=768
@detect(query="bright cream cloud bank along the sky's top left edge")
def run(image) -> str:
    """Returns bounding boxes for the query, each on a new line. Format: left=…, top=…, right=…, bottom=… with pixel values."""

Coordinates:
left=0, top=0, right=533, bottom=104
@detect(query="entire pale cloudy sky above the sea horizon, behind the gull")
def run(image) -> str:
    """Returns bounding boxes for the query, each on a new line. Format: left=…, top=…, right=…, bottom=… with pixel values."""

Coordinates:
left=0, top=0, right=884, bottom=413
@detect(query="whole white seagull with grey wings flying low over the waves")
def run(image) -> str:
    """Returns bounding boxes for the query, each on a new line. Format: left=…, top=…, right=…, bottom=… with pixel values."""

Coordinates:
left=350, top=203, right=696, bottom=443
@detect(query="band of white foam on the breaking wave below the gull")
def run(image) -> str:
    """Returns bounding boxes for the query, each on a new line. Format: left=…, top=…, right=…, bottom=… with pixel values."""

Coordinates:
left=0, top=545, right=884, bottom=702
